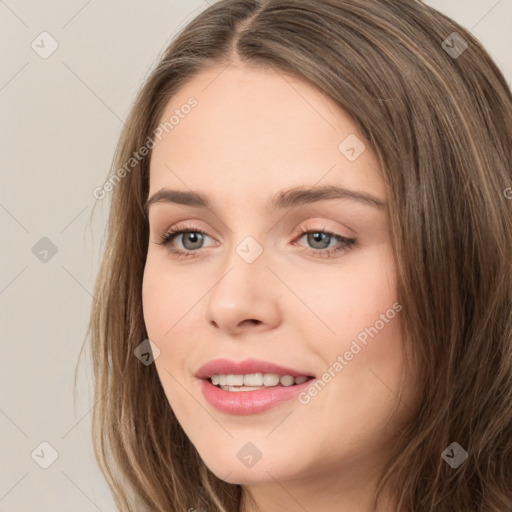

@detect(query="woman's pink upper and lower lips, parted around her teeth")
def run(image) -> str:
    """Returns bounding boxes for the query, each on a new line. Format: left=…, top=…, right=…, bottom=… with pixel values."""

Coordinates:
left=196, top=359, right=311, bottom=414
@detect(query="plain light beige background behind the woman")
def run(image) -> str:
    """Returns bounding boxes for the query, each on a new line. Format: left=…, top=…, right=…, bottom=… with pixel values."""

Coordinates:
left=0, top=0, right=512, bottom=512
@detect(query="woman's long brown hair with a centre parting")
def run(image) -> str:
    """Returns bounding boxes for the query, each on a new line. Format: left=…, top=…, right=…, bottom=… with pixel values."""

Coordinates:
left=87, top=0, right=512, bottom=512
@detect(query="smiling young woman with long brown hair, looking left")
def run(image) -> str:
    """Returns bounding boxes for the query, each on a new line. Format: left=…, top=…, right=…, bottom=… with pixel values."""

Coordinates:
left=90, top=0, right=512, bottom=512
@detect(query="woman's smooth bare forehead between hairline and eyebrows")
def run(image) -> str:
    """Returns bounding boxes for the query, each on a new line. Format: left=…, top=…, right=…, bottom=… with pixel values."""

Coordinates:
left=150, top=64, right=385, bottom=204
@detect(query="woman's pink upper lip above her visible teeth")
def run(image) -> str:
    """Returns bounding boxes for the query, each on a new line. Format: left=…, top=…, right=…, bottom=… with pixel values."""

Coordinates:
left=196, top=359, right=313, bottom=379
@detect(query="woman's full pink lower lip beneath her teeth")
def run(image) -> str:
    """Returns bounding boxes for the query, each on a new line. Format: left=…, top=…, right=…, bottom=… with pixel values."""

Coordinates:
left=201, top=379, right=313, bottom=414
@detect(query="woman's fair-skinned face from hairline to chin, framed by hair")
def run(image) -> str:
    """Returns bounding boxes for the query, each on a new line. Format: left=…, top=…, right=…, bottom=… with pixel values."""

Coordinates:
left=143, top=64, right=414, bottom=504
